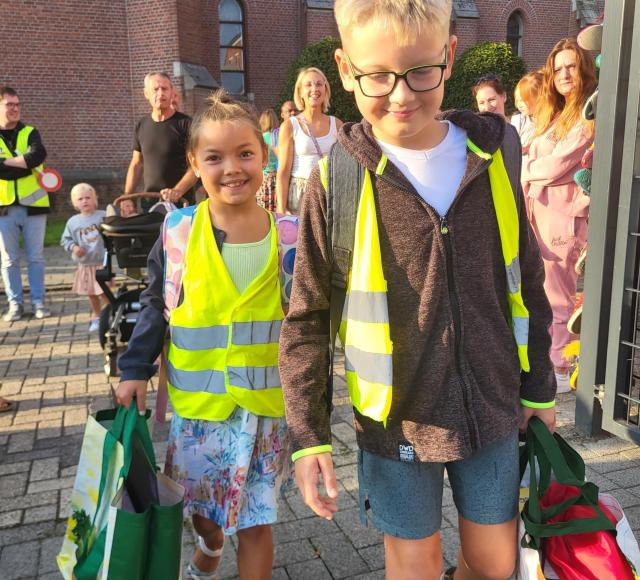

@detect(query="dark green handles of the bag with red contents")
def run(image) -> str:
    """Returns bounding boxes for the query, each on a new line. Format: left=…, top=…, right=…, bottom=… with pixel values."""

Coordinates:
left=520, top=417, right=616, bottom=550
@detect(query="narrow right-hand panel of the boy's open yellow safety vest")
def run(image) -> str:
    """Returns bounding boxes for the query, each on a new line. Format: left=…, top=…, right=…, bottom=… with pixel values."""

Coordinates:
left=467, top=140, right=530, bottom=372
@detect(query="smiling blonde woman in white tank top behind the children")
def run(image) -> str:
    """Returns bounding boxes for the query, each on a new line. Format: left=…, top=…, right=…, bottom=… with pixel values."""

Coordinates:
left=276, top=67, right=342, bottom=213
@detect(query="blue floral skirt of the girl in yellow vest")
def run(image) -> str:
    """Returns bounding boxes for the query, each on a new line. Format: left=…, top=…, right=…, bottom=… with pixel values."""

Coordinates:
left=165, top=407, right=293, bottom=535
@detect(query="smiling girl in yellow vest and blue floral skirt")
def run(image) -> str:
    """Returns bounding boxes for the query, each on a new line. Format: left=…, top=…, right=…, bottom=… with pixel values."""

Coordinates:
left=117, top=91, right=297, bottom=580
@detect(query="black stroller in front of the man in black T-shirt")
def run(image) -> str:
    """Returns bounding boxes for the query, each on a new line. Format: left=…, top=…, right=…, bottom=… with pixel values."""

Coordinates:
left=96, top=193, right=176, bottom=377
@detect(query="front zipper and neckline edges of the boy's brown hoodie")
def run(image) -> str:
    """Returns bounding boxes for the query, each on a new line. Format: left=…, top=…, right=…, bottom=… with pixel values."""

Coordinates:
left=379, top=161, right=490, bottom=451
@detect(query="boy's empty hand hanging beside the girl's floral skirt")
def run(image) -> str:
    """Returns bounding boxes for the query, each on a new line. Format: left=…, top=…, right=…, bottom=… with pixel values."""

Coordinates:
left=295, top=453, right=338, bottom=520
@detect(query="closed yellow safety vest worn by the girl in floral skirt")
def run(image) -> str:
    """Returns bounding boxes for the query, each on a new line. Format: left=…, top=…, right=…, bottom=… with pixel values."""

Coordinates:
left=167, top=203, right=284, bottom=421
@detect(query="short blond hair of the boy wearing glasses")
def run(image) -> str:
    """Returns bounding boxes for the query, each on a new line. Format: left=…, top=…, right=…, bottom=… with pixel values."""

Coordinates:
left=334, top=0, right=451, bottom=46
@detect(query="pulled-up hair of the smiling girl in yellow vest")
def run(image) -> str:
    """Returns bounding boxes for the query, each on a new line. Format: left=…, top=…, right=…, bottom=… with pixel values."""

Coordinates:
left=187, top=89, right=266, bottom=155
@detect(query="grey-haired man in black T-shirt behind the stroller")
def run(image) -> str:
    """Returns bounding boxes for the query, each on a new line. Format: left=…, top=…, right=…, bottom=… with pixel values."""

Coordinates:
left=124, top=73, right=197, bottom=210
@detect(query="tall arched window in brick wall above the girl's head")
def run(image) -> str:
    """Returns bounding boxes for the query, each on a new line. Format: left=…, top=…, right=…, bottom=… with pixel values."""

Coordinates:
left=218, top=0, right=245, bottom=95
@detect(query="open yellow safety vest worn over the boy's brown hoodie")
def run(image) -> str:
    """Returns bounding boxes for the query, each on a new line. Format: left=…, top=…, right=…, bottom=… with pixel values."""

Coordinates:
left=320, top=140, right=529, bottom=425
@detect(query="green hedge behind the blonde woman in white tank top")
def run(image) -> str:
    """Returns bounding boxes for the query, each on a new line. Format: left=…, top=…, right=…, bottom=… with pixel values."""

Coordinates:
left=276, top=36, right=362, bottom=121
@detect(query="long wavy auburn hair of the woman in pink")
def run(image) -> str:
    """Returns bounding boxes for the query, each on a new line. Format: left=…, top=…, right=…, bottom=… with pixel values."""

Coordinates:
left=536, top=38, right=598, bottom=141
